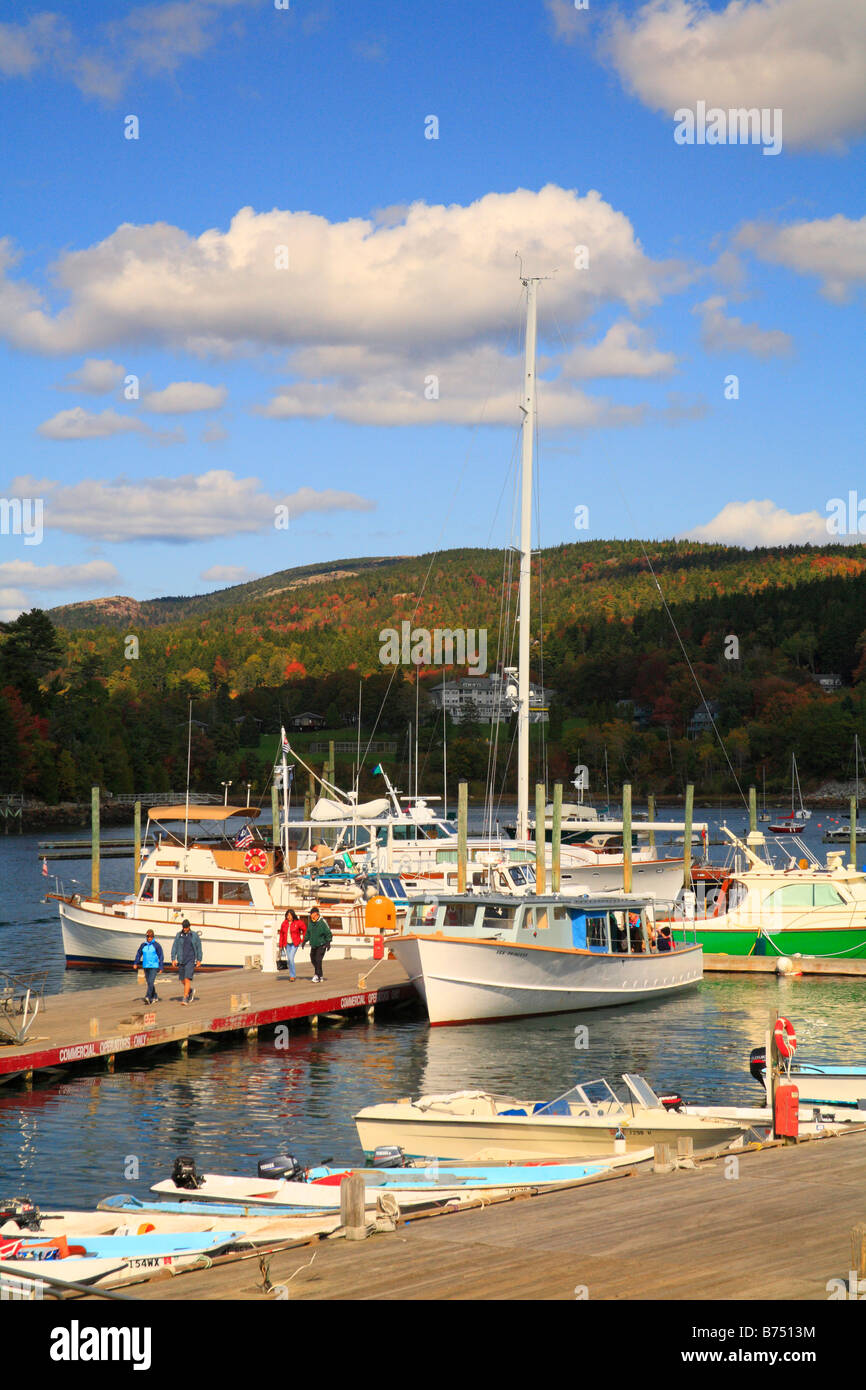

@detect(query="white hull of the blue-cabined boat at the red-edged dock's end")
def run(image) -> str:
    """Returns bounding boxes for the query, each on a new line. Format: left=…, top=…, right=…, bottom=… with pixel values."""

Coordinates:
left=389, top=935, right=703, bottom=1027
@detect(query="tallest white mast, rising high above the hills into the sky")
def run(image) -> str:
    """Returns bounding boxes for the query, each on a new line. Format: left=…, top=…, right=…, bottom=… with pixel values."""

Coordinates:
left=517, top=277, right=538, bottom=841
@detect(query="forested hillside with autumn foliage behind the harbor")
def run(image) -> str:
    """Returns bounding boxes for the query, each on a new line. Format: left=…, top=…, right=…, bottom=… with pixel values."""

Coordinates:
left=0, top=541, right=866, bottom=802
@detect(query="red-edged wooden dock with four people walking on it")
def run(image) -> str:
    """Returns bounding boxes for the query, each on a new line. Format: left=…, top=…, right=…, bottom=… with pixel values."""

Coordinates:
left=0, top=954, right=416, bottom=1083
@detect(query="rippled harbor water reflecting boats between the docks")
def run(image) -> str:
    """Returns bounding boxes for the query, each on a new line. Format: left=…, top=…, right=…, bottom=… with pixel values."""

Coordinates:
left=0, top=810, right=866, bottom=1207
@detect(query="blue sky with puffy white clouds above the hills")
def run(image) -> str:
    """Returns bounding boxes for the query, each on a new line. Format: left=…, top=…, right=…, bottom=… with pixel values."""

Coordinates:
left=0, top=0, right=866, bottom=617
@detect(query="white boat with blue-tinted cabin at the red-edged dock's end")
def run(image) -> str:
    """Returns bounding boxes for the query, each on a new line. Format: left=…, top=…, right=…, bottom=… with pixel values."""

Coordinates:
left=388, top=894, right=703, bottom=1026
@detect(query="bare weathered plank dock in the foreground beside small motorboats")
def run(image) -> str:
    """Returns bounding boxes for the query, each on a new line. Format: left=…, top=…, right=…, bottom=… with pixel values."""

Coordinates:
left=118, top=1130, right=866, bottom=1302
